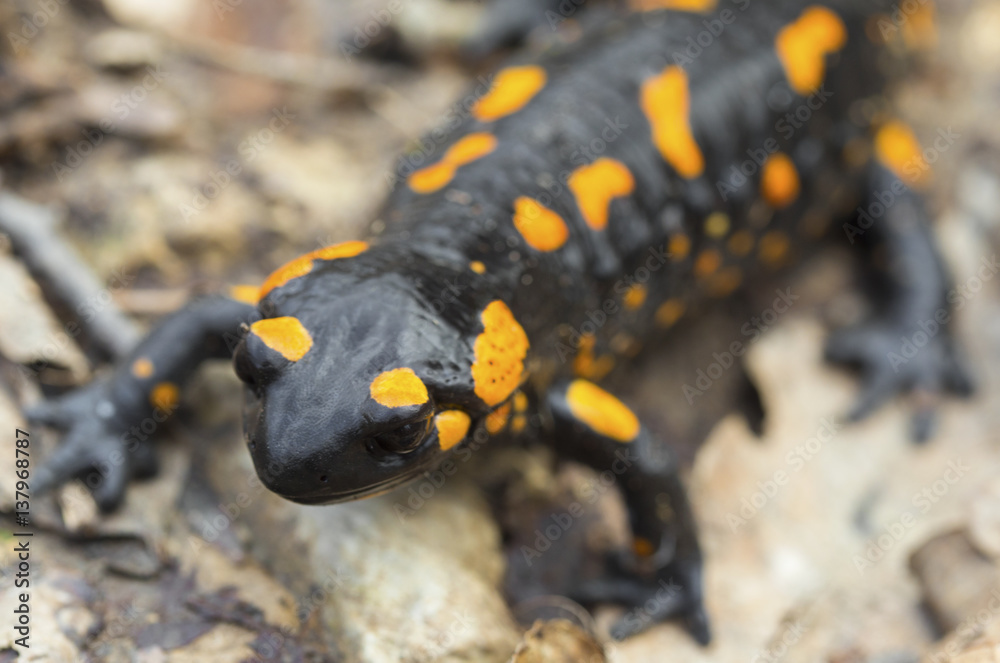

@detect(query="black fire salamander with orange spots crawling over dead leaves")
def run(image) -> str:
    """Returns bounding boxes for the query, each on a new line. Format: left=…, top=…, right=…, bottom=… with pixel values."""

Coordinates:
left=29, top=0, right=971, bottom=643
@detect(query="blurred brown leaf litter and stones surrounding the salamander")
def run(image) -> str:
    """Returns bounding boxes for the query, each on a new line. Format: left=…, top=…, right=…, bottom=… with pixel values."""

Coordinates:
left=0, top=0, right=1000, bottom=663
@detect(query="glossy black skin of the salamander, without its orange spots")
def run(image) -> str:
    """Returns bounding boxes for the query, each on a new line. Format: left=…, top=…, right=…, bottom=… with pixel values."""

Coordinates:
left=29, top=2, right=970, bottom=643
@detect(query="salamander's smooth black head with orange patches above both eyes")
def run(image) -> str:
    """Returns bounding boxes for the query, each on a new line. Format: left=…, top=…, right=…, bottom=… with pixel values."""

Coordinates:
left=234, top=261, right=523, bottom=504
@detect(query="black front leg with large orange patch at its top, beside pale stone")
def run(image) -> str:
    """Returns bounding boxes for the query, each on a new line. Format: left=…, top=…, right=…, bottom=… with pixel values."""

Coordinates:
left=548, top=380, right=711, bottom=644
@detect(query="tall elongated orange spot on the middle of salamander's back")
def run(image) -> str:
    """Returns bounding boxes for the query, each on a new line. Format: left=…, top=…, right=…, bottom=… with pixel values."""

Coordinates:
left=640, top=65, right=705, bottom=179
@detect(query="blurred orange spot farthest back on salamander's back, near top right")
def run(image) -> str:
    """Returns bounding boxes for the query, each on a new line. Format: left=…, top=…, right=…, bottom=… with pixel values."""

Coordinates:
left=775, top=5, right=847, bottom=95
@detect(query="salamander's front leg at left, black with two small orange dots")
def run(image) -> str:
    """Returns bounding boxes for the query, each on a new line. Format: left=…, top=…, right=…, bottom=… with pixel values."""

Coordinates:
left=25, top=297, right=256, bottom=511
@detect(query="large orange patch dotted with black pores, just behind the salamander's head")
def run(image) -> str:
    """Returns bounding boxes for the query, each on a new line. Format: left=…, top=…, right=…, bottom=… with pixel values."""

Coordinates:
left=472, top=299, right=528, bottom=407
